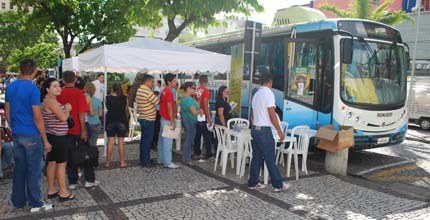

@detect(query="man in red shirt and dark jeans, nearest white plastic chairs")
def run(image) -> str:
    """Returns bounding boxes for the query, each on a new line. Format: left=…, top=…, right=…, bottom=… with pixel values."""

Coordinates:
left=194, top=75, right=213, bottom=160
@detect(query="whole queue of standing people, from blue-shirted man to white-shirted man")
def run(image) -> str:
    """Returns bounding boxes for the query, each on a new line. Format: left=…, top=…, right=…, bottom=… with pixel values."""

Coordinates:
left=1, top=60, right=288, bottom=212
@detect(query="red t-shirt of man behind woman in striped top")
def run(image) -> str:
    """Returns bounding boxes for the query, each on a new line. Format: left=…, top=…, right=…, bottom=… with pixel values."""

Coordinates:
left=57, top=87, right=89, bottom=135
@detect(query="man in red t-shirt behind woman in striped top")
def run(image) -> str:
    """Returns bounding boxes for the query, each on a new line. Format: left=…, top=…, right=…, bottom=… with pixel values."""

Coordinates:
left=57, top=71, right=96, bottom=189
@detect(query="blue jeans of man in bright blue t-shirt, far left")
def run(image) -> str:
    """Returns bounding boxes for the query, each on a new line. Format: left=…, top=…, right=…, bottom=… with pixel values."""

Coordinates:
left=12, top=135, right=43, bottom=208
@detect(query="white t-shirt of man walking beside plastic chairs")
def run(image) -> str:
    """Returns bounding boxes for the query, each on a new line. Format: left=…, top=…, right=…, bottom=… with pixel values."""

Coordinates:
left=252, top=86, right=276, bottom=127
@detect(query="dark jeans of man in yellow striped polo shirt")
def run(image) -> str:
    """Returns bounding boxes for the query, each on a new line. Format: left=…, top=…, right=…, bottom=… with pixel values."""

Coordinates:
left=139, top=119, right=155, bottom=166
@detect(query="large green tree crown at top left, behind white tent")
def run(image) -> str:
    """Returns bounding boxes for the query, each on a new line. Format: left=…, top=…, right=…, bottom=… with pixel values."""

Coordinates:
left=14, top=0, right=159, bottom=58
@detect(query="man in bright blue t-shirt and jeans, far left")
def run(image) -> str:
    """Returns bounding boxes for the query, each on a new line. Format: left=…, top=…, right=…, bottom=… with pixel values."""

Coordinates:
left=5, top=59, right=53, bottom=212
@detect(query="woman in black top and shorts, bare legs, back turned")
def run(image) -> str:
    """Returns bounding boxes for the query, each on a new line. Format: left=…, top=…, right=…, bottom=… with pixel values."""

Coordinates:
left=105, top=83, right=130, bottom=168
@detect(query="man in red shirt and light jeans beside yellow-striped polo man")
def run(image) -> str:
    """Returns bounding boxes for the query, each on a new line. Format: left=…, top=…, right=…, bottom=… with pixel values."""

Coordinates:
left=157, top=73, right=179, bottom=169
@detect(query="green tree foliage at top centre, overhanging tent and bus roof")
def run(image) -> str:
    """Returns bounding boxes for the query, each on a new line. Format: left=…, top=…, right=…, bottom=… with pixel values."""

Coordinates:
left=136, top=0, right=263, bottom=41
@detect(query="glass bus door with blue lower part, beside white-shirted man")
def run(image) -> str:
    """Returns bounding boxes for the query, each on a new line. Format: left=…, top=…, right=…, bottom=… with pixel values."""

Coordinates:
left=283, top=38, right=319, bottom=129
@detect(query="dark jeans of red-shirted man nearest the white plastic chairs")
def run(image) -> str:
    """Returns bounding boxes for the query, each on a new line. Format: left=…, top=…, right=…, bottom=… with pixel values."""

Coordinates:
left=194, top=122, right=213, bottom=158
